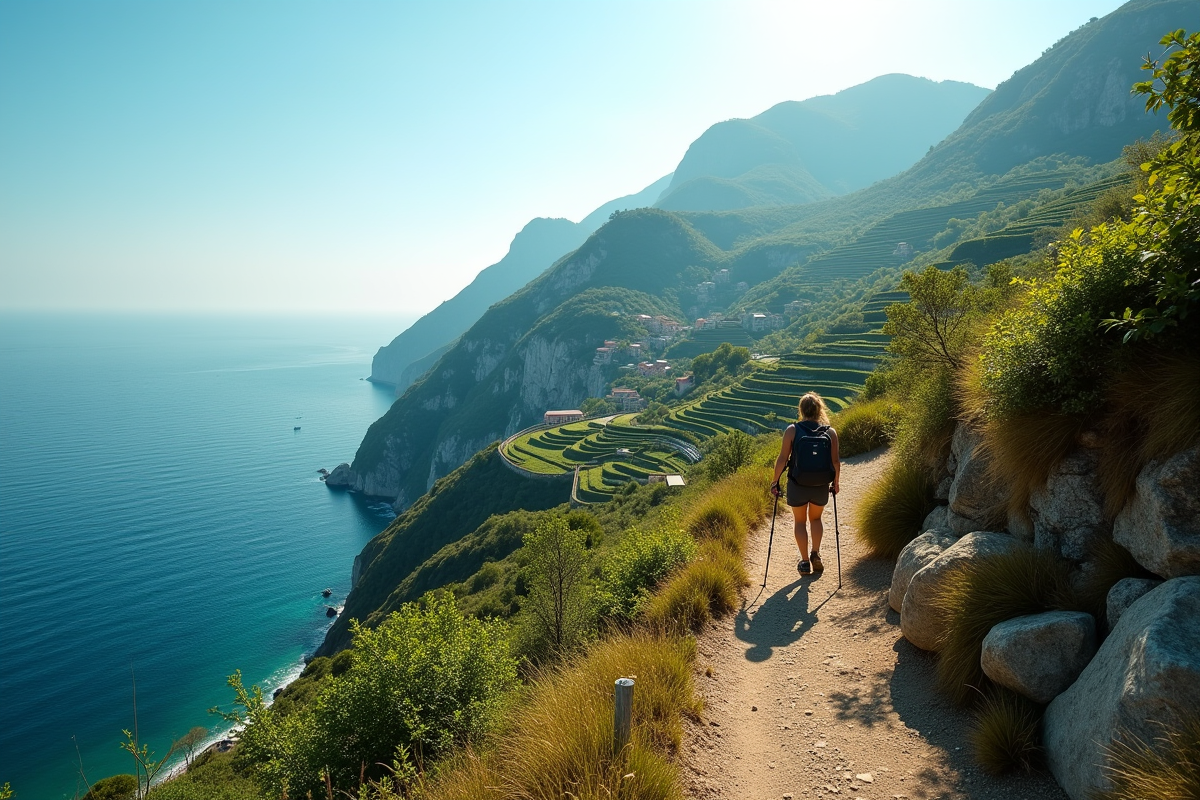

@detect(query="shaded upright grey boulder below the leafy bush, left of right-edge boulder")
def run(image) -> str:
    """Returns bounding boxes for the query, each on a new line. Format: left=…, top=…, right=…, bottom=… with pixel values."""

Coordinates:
left=1030, top=449, right=1108, bottom=561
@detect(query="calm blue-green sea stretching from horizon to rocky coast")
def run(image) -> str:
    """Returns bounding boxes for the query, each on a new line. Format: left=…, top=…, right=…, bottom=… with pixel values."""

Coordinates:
left=0, top=313, right=412, bottom=800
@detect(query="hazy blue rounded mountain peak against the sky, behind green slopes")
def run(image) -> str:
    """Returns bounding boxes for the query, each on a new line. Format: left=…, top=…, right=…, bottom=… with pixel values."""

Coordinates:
left=658, top=74, right=988, bottom=211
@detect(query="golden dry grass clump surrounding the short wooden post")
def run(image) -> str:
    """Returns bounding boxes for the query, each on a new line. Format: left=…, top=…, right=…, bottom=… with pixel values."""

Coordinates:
left=425, top=634, right=701, bottom=800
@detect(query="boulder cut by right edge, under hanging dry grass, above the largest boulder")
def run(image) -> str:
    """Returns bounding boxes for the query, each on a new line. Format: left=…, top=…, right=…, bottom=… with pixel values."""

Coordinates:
left=1112, top=445, right=1200, bottom=578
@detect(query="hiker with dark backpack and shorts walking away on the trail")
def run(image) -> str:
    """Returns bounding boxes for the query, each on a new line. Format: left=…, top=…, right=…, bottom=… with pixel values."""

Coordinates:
left=770, top=392, right=841, bottom=575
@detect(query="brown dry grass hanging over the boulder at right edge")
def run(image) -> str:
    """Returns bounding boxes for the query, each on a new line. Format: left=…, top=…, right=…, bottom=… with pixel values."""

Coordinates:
left=1099, top=351, right=1200, bottom=517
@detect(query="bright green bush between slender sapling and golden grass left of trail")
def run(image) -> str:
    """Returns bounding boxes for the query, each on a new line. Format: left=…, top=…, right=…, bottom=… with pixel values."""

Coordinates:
left=598, top=524, right=696, bottom=619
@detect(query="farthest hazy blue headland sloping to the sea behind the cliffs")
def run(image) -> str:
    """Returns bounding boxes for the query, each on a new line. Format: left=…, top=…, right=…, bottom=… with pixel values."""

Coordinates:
left=371, top=175, right=671, bottom=392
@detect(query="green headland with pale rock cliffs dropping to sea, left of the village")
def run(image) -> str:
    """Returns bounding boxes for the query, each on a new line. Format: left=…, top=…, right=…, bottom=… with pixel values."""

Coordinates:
left=343, top=209, right=721, bottom=507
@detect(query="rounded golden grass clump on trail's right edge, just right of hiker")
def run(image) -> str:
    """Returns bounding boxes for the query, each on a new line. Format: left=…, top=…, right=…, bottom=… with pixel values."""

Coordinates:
left=856, top=458, right=935, bottom=559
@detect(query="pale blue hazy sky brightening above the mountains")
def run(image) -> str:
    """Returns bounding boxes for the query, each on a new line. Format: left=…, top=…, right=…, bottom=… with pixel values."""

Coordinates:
left=0, top=0, right=1120, bottom=313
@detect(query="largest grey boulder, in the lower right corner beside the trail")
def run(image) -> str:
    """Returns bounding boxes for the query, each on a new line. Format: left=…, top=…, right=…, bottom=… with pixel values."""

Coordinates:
left=1043, top=577, right=1200, bottom=800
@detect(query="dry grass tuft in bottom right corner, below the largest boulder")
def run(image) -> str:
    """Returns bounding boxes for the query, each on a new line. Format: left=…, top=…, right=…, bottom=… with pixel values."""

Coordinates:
left=1096, top=710, right=1200, bottom=800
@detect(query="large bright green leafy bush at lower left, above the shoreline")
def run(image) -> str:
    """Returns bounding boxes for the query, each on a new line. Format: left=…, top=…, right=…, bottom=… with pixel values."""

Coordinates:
left=227, top=596, right=516, bottom=796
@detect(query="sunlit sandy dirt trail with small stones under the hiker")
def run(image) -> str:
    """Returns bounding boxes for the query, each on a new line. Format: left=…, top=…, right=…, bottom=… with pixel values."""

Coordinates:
left=683, top=451, right=1066, bottom=800
